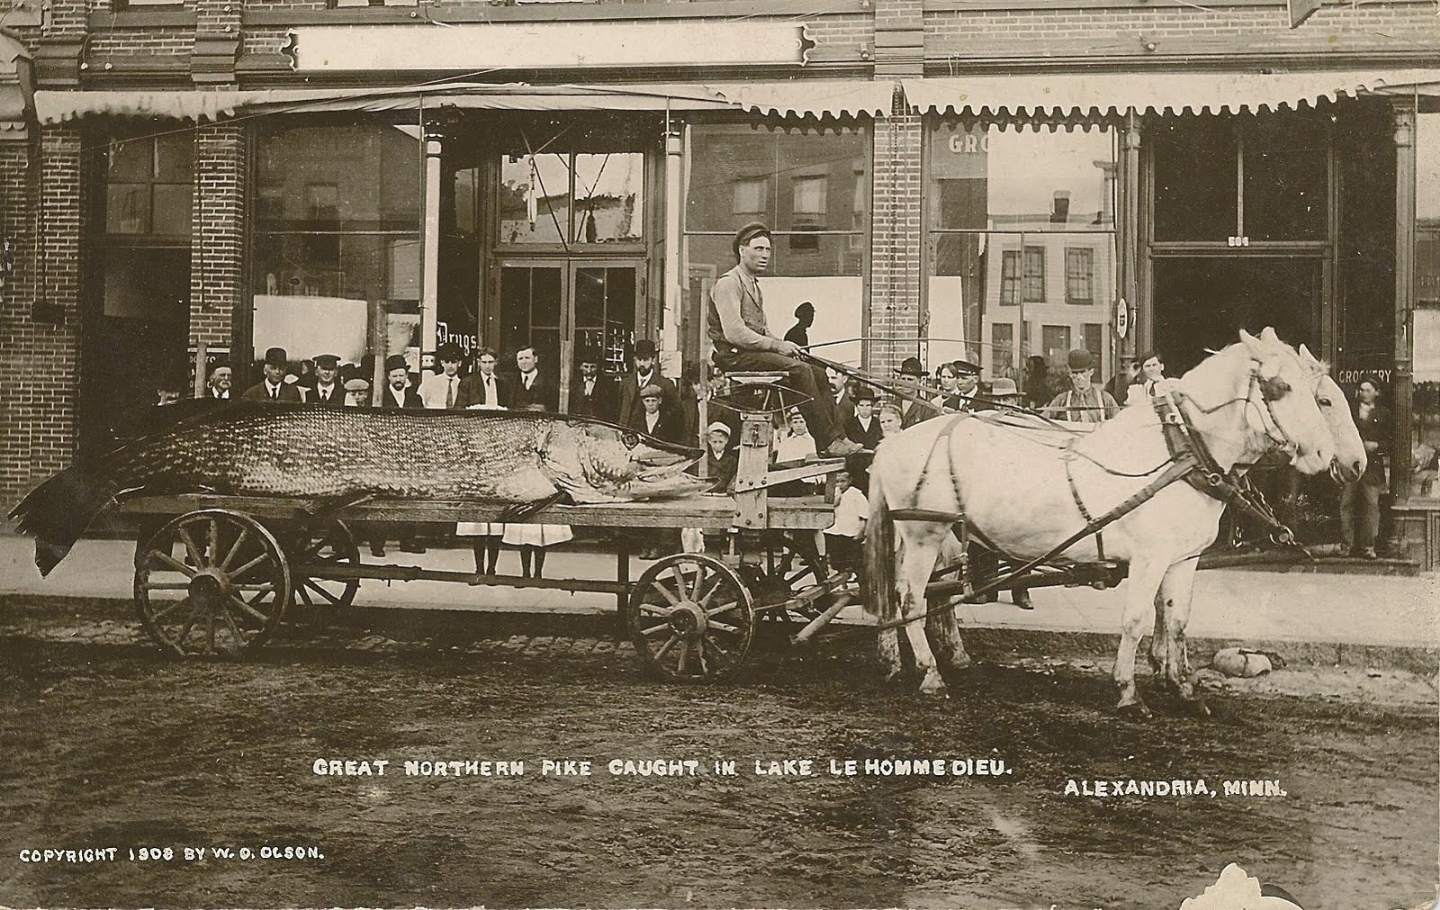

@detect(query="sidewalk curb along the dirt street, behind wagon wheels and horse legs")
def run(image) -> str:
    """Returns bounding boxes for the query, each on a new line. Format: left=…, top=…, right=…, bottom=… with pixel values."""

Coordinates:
left=8, top=595, right=1440, bottom=677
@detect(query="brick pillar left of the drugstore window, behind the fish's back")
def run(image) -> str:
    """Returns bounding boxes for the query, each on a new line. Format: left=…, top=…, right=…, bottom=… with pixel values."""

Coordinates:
left=190, top=122, right=249, bottom=365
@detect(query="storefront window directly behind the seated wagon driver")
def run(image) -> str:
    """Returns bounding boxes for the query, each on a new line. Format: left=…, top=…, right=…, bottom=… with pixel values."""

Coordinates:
left=685, top=124, right=870, bottom=364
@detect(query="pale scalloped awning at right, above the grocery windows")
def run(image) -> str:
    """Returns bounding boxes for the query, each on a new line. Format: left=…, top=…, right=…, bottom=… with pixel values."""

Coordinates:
left=904, top=69, right=1437, bottom=117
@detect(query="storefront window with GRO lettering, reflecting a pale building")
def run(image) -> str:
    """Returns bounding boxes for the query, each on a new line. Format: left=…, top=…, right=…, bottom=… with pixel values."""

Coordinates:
left=923, top=122, right=1116, bottom=382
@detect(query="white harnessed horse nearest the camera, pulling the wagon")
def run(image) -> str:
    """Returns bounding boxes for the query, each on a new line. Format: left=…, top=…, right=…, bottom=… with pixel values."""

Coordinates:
left=865, top=328, right=1365, bottom=711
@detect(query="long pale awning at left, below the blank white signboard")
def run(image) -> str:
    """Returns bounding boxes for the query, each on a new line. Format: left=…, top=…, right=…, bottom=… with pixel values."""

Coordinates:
left=35, top=81, right=894, bottom=124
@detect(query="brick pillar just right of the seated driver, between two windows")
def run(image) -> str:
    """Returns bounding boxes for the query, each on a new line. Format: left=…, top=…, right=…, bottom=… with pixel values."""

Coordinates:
left=865, top=89, right=924, bottom=371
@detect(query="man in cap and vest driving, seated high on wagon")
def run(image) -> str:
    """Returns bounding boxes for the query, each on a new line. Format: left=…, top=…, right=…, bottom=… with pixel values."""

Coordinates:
left=707, top=222, right=860, bottom=455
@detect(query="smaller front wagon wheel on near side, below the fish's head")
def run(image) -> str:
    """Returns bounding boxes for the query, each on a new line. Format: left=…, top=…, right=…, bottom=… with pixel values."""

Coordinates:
left=622, top=553, right=755, bottom=683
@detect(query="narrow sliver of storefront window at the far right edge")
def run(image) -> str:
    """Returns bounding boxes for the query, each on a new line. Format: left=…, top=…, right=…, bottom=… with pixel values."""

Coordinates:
left=1410, top=109, right=1440, bottom=498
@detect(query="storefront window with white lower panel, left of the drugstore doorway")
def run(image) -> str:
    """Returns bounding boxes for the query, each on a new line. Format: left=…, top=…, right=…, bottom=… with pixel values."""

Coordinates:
left=253, top=120, right=420, bottom=369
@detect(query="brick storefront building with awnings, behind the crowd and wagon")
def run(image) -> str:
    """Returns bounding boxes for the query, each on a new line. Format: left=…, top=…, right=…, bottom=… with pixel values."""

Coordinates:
left=0, top=0, right=1440, bottom=559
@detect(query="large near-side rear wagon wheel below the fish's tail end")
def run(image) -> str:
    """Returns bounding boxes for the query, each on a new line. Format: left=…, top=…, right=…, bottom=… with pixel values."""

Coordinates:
left=135, top=508, right=292, bottom=657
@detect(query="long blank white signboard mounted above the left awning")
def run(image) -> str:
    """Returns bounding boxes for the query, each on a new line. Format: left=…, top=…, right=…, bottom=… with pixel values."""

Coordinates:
left=288, top=22, right=815, bottom=72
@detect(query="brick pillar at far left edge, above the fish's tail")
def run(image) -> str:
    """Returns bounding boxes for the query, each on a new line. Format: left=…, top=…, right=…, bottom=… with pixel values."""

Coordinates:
left=0, top=127, right=82, bottom=508
